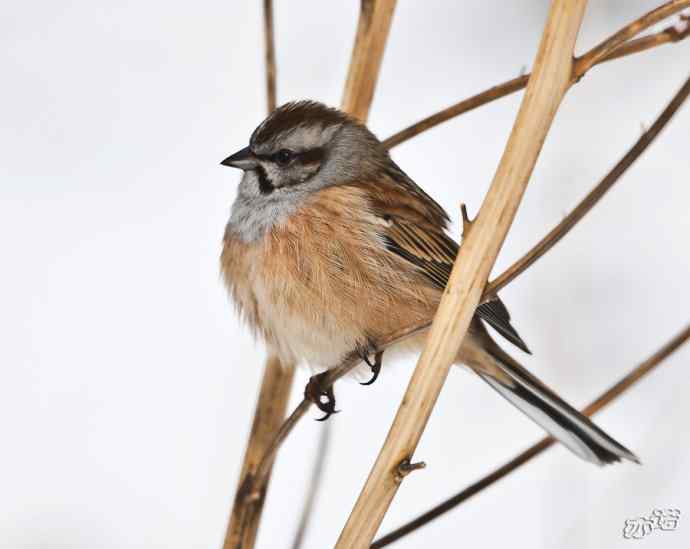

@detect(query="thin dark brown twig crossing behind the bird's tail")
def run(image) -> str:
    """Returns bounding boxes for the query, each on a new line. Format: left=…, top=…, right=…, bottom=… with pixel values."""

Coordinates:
left=371, top=325, right=690, bottom=549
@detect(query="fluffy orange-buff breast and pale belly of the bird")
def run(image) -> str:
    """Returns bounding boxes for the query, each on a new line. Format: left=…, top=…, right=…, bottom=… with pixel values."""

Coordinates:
left=221, top=187, right=438, bottom=367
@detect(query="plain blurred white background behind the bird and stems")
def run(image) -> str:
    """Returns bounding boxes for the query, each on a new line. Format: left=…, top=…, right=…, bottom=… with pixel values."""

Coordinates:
left=0, top=0, right=690, bottom=549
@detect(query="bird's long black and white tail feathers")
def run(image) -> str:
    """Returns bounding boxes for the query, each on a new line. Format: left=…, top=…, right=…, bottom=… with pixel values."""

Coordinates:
left=477, top=345, right=640, bottom=465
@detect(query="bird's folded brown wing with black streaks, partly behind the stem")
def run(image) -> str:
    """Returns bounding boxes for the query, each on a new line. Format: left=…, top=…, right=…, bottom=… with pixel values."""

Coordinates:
left=358, top=176, right=530, bottom=353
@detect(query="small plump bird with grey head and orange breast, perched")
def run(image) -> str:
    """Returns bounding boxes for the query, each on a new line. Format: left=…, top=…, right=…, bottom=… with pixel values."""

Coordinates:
left=221, top=101, right=639, bottom=465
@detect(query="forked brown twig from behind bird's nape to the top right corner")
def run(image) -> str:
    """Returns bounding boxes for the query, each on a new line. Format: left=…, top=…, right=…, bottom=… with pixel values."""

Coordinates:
left=383, top=4, right=690, bottom=149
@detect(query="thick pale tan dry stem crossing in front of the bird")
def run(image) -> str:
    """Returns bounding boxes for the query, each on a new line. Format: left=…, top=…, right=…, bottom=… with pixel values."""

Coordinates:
left=336, top=0, right=586, bottom=549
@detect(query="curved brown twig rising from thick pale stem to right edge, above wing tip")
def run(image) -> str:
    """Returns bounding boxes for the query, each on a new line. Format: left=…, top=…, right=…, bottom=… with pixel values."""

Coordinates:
left=484, top=74, right=690, bottom=296
